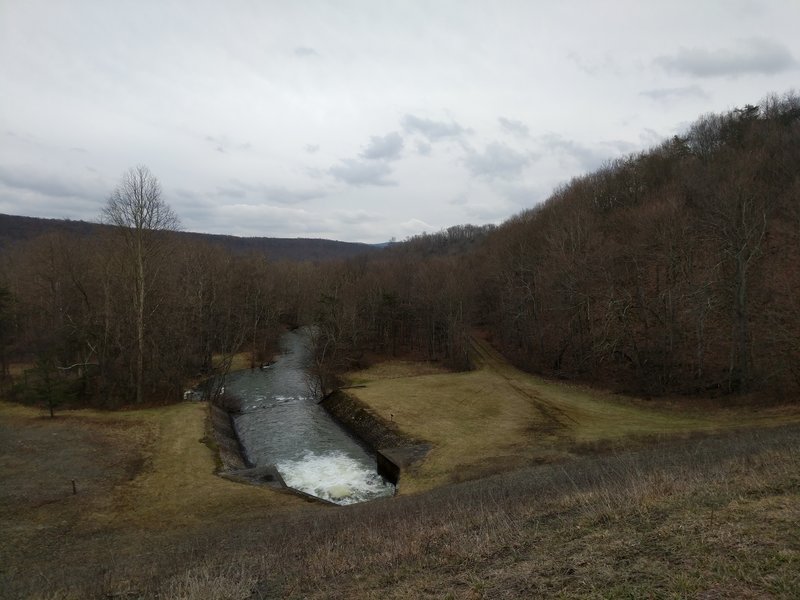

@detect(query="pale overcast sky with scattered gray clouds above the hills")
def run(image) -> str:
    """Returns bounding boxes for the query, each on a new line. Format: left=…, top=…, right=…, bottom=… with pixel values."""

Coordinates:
left=0, top=0, right=800, bottom=242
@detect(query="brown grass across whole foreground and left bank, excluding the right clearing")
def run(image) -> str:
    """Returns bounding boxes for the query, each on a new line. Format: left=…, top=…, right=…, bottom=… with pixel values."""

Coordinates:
left=6, top=404, right=800, bottom=599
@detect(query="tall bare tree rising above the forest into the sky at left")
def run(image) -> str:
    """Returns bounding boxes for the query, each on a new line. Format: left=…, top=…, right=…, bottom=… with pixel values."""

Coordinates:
left=102, top=165, right=180, bottom=403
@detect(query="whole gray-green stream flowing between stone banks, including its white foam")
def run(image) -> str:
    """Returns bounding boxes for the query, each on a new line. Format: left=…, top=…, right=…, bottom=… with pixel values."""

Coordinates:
left=225, top=329, right=394, bottom=504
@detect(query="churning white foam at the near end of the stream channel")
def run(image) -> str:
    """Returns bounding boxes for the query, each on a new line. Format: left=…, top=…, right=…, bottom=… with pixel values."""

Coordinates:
left=275, top=452, right=394, bottom=504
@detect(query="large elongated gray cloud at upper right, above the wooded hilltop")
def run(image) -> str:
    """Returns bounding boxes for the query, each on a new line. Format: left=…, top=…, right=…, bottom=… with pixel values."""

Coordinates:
left=655, top=38, right=798, bottom=77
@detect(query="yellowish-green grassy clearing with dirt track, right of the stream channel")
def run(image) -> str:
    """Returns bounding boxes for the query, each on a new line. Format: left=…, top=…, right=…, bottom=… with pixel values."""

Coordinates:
left=350, top=338, right=800, bottom=493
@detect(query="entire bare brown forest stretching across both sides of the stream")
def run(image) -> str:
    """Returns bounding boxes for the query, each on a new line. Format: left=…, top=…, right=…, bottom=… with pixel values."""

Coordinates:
left=0, top=94, right=800, bottom=406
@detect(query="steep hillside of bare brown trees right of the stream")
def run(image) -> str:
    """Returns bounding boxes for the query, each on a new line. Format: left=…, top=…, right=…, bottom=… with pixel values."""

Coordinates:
left=308, top=94, right=800, bottom=395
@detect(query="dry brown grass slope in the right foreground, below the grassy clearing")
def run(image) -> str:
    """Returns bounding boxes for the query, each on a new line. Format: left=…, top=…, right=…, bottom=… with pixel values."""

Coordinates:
left=134, top=428, right=800, bottom=599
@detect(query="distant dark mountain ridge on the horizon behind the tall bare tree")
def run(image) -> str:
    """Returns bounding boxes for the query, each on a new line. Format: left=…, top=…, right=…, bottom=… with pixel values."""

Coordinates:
left=0, top=214, right=379, bottom=261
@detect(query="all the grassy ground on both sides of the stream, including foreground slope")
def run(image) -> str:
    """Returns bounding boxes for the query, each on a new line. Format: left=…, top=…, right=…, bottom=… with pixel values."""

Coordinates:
left=0, top=341, right=800, bottom=600
